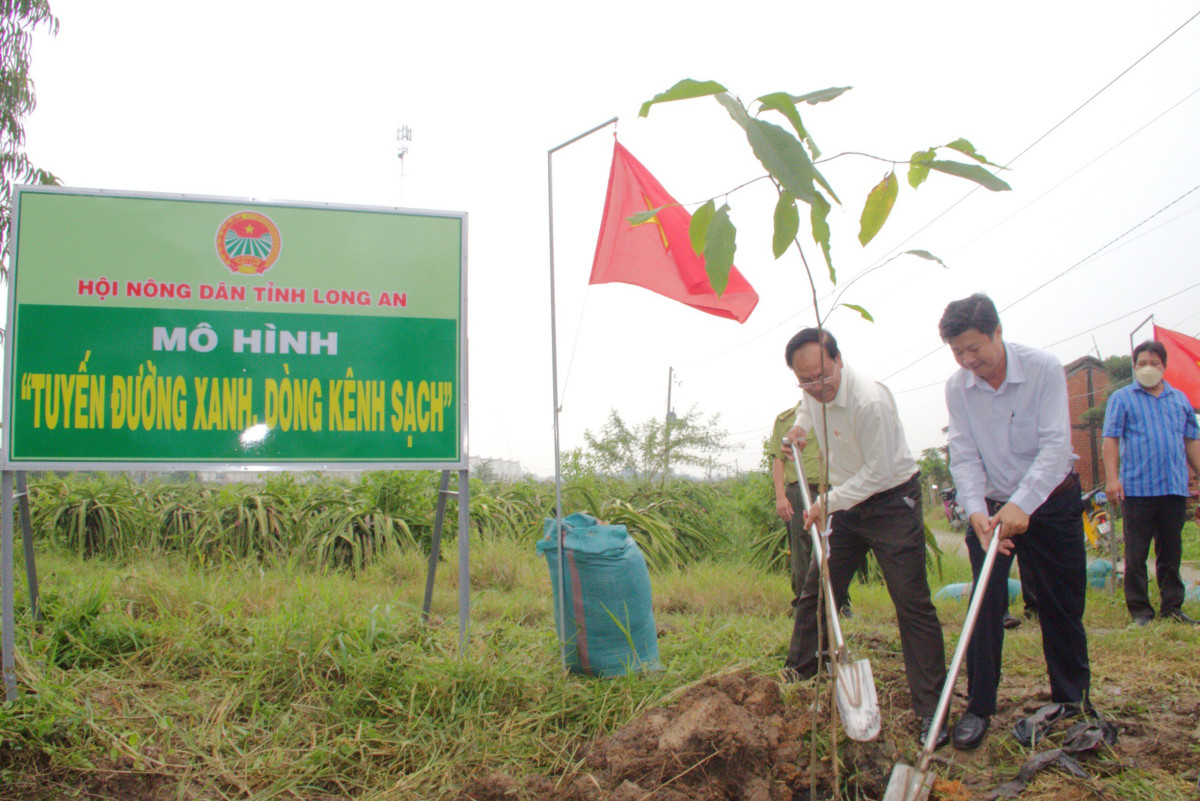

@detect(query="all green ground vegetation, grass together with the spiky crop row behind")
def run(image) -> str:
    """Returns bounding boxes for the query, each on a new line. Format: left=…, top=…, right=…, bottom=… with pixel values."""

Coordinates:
left=0, top=472, right=1200, bottom=801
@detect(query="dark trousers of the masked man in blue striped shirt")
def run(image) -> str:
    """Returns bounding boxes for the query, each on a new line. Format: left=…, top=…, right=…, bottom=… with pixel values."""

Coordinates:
left=1121, top=495, right=1188, bottom=618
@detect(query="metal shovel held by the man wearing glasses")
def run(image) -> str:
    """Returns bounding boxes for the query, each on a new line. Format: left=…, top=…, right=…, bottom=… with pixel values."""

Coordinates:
left=791, top=442, right=880, bottom=742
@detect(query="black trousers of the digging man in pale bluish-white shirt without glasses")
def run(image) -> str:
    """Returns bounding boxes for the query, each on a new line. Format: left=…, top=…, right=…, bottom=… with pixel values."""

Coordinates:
left=966, top=484, right=1092, bottom=716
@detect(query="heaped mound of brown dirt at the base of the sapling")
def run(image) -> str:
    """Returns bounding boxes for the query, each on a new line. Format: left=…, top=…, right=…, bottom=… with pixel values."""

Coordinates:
left=460, top=673, right=890, bottom=801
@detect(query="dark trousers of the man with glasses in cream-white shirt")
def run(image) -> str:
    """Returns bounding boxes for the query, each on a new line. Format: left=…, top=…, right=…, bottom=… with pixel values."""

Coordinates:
left=785, top=476, right=946, bottom=716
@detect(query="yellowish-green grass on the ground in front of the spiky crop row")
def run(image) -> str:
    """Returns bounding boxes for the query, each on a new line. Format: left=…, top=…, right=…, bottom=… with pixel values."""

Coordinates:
left=0, top=538, right=1200, bottom=801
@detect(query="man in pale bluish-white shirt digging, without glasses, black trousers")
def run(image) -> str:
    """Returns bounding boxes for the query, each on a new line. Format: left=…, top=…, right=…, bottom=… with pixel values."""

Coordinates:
left=938, top=294, right=1091, bottom=749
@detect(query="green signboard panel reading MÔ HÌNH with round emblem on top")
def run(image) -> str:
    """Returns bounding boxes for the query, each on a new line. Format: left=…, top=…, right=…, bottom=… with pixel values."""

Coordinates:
left=4, top=187, right=467, bottom=469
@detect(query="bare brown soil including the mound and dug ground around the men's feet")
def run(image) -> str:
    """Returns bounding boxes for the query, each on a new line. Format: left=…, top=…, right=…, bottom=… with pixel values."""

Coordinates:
left=457, top=664, right=1200, bottom=801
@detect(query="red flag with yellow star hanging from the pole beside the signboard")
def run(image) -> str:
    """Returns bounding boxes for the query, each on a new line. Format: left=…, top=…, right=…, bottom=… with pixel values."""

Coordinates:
left=588, top=141, right=758, bottom=323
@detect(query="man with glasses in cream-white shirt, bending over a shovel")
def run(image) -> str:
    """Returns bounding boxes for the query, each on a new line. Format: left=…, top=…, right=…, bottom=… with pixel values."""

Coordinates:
left=784, top=329, right=947, bottom=746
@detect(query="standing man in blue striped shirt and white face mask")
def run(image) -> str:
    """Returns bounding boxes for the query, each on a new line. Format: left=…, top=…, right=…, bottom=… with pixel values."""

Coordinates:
left=1104, top=341, right=1200, bottom=626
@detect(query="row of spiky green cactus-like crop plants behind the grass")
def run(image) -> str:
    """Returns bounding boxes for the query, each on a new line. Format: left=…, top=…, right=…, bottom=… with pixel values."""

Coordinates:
left=30, top=472, right=782, bottom=572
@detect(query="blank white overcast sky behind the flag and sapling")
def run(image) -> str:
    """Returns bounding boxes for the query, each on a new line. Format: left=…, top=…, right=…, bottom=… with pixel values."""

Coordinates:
left=18, top=0, right=1200, bottom=475
